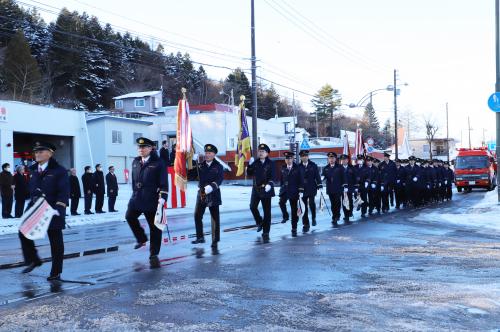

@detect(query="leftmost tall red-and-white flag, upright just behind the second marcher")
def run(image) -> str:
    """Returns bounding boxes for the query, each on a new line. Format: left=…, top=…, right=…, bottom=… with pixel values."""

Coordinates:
left=174, top=98, right=194, bottom=191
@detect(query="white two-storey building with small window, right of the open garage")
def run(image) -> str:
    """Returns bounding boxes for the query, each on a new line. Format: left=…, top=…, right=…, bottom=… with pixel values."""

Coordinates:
left=87, top=115, right=154, bottom=183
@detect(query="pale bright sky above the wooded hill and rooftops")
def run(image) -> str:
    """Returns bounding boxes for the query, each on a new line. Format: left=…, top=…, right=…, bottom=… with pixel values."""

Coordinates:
left=23, top=0, right=495, bottom=145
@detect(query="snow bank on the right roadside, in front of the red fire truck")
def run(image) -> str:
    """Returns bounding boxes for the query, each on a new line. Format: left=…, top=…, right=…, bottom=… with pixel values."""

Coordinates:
left=415, top=190, right=500, bottom=231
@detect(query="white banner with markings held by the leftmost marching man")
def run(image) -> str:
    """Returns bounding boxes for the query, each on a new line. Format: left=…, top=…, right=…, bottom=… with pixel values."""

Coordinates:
left=19, top=197, right=59, bottom=240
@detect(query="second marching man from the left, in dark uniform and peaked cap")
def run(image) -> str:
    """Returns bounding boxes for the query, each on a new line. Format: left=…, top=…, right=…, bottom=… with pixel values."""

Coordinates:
left=125, top=137, right=168, bottom=268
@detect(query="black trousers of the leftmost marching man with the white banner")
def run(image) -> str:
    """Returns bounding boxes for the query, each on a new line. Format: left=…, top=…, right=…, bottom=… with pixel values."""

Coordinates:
left=19, top=229, right=64, bottom=276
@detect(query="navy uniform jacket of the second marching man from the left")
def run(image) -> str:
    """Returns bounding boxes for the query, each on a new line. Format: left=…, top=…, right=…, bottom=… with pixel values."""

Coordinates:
left=128, top=152, right=168, bottom=212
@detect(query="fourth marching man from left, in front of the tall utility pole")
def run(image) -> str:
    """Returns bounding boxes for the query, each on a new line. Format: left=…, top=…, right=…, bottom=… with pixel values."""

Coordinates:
left=247, top=144, right=275, bottom=240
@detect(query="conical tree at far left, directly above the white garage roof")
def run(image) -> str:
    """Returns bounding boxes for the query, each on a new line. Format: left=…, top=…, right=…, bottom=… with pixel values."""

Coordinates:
left=3, top=31, right=41, bottom=102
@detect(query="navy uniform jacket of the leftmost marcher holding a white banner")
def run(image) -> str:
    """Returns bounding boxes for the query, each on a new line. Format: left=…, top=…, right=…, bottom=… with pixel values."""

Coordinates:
left=29, top=158, right=69, bottom=229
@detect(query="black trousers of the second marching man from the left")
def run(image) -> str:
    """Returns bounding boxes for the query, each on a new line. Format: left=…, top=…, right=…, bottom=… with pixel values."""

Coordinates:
left=125, top=208, right=162, bottom=256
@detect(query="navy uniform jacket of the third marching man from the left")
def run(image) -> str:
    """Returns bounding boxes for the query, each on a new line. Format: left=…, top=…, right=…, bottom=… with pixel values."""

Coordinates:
left=197, top=159, right=224, bottom=207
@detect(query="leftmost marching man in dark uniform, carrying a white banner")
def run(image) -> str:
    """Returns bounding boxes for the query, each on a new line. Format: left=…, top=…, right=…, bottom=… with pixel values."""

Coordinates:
left=19, top=142, right=69, bottom=281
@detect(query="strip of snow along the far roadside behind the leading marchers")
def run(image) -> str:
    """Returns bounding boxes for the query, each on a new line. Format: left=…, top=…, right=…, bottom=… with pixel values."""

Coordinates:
left=0, top=182, right=251, bottom=235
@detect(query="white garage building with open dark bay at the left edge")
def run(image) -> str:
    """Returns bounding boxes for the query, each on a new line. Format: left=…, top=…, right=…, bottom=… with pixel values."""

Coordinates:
left=0, top=100, right=93, bottom=168
